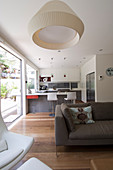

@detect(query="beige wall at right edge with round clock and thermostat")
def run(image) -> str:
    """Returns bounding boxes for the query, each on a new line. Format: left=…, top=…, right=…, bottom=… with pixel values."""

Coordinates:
left=96, top=55, right=113, bottom=102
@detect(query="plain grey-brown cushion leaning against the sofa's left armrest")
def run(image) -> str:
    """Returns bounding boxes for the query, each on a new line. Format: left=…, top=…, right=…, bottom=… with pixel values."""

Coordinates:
left=61, top=103, right=75, bottom=131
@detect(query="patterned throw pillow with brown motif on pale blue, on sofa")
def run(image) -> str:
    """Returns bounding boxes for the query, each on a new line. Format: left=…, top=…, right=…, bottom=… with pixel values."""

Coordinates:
left=70, top=106, right=95, bottom=124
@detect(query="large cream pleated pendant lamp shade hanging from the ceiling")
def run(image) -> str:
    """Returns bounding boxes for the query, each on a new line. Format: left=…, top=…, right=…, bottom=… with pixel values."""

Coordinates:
left=28, top=0, right=84, bottom=50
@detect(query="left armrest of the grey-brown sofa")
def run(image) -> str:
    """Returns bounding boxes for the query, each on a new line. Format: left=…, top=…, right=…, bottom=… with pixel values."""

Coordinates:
left=55, top=105, right=69, bottom=146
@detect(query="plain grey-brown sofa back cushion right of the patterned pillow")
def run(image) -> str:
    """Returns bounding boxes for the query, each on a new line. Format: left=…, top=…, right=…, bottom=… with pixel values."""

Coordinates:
left=91, top=102, right=113, bottom=120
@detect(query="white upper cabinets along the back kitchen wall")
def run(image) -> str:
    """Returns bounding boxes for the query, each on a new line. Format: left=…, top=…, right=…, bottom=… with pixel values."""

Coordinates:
left=40, top=68, right=80, bottom=82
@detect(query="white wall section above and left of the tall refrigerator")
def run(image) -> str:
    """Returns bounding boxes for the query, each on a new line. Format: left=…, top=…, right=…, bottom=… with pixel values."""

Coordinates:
left=80, top=56, right=96, bottom=102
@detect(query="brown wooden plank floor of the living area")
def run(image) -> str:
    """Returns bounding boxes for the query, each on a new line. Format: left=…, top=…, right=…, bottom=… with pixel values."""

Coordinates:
left=11, top=113, right=113, bottom=170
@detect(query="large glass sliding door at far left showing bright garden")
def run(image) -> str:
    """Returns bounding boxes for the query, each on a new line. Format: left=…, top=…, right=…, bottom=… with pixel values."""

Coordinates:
left=0, top=47, right=22, bottom=126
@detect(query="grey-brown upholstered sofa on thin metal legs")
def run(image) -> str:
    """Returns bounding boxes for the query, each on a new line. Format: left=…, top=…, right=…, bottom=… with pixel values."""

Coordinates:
left=55, top=102, right=113, bottom=146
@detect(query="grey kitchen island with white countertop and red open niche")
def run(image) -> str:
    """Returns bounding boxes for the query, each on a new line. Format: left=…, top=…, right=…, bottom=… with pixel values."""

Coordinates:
left=26, top=89, right=81, bottom=113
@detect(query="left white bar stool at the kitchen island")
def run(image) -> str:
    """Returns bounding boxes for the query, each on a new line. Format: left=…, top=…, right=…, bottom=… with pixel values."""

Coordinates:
left=47, top=93, right=58, bottom=117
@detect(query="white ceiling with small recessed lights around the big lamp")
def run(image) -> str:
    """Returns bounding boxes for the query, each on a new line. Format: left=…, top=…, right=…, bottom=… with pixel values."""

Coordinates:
left=0, top=0, right=113, bottom=68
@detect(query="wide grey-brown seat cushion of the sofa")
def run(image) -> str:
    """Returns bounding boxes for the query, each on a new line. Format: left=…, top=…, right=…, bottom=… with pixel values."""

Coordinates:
left=69, top=120, right=113, bottom=140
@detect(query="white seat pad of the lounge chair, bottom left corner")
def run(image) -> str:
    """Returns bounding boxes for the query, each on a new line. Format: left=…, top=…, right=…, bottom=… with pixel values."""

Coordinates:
left=0, top=149, right=23, bottom=169
